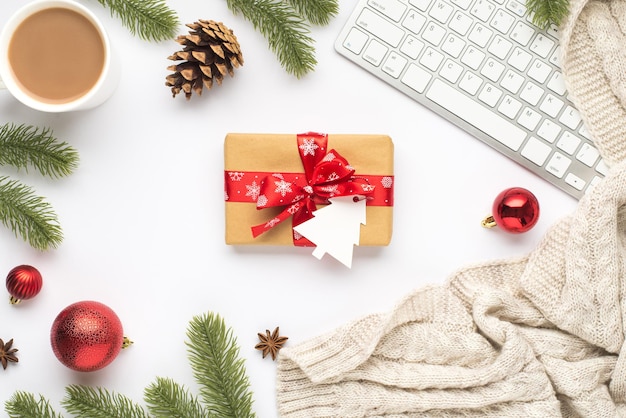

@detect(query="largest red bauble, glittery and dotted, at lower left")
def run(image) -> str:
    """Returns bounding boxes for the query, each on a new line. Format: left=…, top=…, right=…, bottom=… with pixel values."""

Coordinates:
left=50, top=301, right=124, bottom=372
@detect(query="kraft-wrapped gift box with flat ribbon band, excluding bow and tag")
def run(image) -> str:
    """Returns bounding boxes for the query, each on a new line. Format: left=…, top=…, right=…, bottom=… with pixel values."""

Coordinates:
left=224, top=133, right=394, bottom=246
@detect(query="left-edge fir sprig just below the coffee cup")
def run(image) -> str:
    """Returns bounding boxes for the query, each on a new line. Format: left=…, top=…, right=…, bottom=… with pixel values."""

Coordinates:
left=0, top=123, right=78, bottom=177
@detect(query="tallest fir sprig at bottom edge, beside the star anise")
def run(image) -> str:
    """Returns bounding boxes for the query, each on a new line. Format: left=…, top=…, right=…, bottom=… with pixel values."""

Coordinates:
left=187, top=313, right=255, bottom=418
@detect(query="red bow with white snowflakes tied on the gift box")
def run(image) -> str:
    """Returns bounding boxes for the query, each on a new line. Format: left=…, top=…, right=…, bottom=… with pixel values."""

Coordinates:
left=252, top=133, right=374, bottom=242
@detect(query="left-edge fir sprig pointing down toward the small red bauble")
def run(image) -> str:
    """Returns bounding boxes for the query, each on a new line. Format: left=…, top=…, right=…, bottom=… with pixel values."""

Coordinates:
left=0, top=176, right=63, bottom=251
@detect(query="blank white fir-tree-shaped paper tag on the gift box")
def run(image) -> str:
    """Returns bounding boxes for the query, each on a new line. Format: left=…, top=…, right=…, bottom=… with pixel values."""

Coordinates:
left=293, top=196, right=366, bottom=268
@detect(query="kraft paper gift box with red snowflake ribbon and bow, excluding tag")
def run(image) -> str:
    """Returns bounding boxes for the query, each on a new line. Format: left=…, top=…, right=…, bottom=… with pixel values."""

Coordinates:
left=224, top=133, right=394, bottom=246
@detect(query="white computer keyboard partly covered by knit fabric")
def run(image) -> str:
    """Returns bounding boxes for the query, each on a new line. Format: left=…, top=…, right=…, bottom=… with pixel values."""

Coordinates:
left=335, top=0, right=607, bottom=198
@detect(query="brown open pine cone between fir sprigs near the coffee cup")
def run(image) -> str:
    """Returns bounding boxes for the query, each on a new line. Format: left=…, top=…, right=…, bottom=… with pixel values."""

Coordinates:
left=165, top=19, right=243, bottom=100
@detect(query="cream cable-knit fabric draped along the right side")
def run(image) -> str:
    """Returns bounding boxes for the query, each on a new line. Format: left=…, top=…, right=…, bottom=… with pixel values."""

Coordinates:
left=277, top=0, right=626, bottom=418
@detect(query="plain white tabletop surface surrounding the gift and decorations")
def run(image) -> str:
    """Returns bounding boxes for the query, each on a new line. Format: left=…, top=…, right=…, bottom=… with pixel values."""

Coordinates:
left=0, top=0, right=576, bottom=418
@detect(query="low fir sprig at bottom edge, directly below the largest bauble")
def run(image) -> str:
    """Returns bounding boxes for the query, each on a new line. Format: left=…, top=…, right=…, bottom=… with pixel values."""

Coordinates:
left=61, top=385, right=149, bottom=418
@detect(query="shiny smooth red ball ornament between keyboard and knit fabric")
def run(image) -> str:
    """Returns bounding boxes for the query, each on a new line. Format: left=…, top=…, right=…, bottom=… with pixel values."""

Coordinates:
left=482, top=187, right=539, bottom=234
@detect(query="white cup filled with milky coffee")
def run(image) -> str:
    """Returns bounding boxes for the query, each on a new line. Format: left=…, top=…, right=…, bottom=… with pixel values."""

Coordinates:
left=0, top=0, right=119, bottom=112
